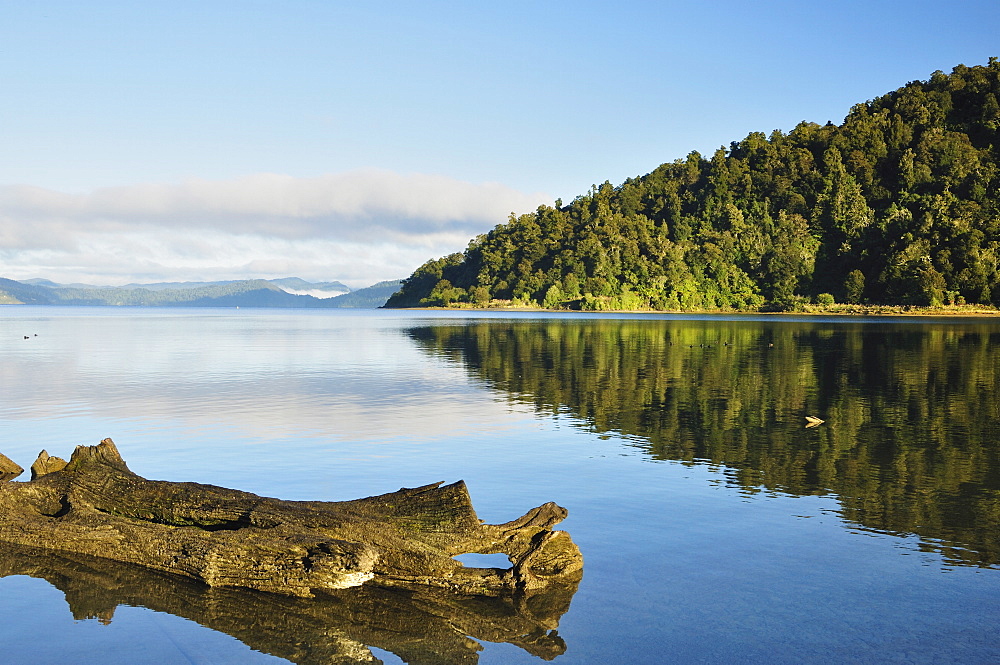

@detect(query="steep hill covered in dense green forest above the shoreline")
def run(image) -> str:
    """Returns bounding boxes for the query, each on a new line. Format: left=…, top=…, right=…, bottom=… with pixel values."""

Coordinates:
left=386, top=58, right=1000, bottom=310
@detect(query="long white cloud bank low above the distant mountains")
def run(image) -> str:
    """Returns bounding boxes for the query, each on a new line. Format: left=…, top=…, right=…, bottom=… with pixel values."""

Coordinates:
left=0, top=169, right=547, bottom=286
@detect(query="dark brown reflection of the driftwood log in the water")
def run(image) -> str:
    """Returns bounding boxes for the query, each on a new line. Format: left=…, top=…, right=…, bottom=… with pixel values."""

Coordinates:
left=0, top=544, right=577, bottom=665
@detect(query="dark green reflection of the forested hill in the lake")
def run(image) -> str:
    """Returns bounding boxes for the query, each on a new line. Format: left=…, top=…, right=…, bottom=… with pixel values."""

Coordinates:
left=408, top=318, right=1000, bottom=566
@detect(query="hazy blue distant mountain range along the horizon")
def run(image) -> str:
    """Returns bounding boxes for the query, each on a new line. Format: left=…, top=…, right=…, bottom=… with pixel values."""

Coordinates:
left=0, top=277, right=400, bottom=309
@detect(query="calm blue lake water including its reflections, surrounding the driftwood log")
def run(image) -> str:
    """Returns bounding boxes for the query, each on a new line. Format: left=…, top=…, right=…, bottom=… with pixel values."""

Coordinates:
left=0, top=306, right=1000, bottom=665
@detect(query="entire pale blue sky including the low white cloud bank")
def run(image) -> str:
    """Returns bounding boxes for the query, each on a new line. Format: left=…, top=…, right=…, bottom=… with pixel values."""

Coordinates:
left=0, top=0, right=1000, bottom=286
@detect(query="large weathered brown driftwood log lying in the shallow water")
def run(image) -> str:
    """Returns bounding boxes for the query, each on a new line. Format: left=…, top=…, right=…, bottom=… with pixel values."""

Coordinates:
left=0, top=439, right=583, bottom=597
